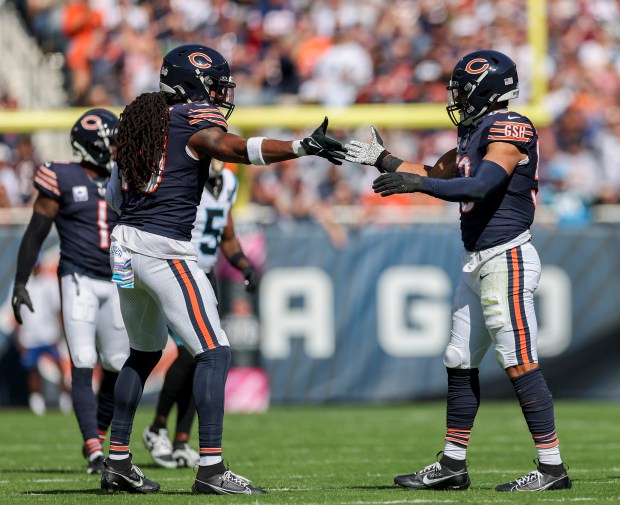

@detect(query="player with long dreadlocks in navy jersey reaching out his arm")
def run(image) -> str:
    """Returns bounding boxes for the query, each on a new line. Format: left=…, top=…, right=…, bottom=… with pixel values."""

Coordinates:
left=101, top=44, right=344, bottom=494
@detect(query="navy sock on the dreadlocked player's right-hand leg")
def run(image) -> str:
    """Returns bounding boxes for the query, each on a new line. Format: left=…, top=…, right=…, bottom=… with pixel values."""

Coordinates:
left=194, top=346, right=231, bottom=456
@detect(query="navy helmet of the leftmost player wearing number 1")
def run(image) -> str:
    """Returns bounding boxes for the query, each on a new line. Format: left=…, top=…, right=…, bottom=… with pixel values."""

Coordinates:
left=71, top=109, right=118, bottom=172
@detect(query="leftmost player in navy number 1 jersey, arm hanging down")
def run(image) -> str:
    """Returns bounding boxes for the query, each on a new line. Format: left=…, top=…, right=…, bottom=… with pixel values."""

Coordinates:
left=12, top=109, right=129, bottom=473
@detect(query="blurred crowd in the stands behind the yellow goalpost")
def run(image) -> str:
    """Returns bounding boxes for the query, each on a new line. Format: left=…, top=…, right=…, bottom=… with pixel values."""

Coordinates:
left=0, top=0, right=620, bottom=226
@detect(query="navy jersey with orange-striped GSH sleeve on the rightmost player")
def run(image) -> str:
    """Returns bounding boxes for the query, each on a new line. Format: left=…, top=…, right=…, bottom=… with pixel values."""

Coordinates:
left=455, top=110, right=538, bottom=251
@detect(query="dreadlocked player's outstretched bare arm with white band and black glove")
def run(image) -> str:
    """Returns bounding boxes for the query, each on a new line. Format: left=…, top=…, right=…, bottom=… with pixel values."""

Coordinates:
left=188, top=118, right=345, bottom=165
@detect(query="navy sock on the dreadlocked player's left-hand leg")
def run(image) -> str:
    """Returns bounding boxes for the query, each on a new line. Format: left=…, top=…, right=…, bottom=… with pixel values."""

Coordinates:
left=110, top=349, right=162, bottom=448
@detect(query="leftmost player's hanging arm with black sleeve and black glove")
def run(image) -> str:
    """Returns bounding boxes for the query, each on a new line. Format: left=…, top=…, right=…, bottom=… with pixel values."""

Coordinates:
left=11, top=193, right=60, bottom=324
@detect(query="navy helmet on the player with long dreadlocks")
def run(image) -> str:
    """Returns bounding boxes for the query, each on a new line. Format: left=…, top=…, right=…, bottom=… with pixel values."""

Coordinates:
left=159, top=44, right=236, bottom=119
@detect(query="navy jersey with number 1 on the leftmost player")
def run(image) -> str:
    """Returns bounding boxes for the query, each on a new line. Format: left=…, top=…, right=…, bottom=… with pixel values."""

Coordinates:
left=34, top=162, right=118, bottom=280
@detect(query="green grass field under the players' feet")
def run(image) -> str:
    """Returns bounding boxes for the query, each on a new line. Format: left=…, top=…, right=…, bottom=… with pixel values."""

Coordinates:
left=0, top=401, right=620, bottom=505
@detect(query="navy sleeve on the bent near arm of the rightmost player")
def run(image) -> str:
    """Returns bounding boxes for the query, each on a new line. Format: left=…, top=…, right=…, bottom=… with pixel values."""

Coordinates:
left=419, top=160, right=508, bottom=202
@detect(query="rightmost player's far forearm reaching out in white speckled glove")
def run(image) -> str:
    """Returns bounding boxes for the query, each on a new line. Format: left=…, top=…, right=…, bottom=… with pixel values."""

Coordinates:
left=344, top=126, right=456, bottom=179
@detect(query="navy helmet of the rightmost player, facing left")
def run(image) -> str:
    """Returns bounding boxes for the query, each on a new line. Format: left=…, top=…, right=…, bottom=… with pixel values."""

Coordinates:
left=446, top=50, right=519, bottom=126
